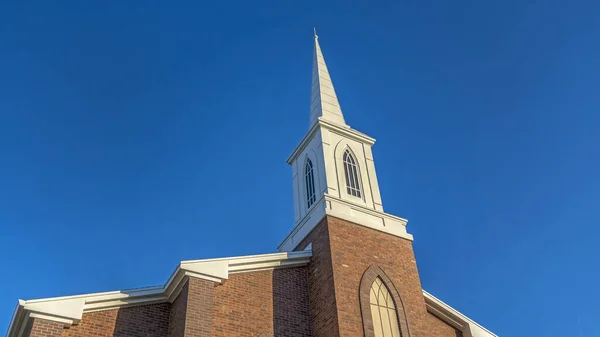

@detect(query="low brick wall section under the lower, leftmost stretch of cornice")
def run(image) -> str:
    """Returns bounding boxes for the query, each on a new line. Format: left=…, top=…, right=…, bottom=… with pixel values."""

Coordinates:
left=61, top=303, right=171, bottom=337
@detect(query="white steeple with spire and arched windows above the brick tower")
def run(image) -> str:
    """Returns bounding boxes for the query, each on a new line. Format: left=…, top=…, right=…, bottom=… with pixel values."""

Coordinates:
left=279, top=33, right=412, bottom=251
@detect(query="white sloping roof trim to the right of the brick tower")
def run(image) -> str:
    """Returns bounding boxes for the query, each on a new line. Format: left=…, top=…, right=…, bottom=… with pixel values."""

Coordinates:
left=423, top=290, right=498, bottom=337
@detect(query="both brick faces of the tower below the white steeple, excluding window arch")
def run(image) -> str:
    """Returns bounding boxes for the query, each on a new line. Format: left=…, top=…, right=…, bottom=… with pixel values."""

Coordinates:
left=298, top=216, right=460, bottom=337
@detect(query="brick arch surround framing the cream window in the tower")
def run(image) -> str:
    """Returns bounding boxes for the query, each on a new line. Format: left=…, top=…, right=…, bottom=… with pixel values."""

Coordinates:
left=358, top=266, right=410, bottom=337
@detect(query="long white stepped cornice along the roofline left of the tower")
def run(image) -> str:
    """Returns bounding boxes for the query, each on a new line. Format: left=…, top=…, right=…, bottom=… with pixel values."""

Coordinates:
left=7, top=250, right=312, bottom=337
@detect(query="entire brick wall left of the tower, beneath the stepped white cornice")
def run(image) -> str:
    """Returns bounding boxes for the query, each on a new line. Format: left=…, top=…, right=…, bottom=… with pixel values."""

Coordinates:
left=26, top=267, right=311, bottom=337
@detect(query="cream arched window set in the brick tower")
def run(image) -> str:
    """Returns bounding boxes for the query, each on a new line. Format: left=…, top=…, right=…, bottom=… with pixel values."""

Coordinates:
left=370, top=277, right=402, bottom=337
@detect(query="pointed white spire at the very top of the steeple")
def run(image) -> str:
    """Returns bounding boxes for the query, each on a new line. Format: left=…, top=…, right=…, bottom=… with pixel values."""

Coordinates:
left=310, top=29, right=346, bottom=126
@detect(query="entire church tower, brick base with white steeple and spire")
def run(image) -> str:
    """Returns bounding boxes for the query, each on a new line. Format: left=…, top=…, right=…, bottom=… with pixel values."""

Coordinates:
left=279, top=34, right=446, bottom=337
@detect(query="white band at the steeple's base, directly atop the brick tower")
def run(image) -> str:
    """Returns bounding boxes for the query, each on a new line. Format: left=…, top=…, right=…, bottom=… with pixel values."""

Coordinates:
left=278, top=194, right=413, bottom=252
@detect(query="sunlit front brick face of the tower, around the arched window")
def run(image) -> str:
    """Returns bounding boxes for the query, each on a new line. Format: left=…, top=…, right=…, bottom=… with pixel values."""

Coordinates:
left=327, top=217, right=428, bottom=337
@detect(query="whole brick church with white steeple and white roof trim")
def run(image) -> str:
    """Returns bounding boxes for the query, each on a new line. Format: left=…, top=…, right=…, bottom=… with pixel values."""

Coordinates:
left=7, top=34, right=496, bottom=337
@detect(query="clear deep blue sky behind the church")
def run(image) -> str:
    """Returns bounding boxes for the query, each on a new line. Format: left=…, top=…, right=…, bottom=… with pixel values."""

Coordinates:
left=0, top=0, right=600, bottom=337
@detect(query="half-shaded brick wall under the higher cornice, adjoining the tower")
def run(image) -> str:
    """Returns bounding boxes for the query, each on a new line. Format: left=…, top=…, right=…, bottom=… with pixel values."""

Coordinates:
left=211, top=268, right=310, bottom=337
